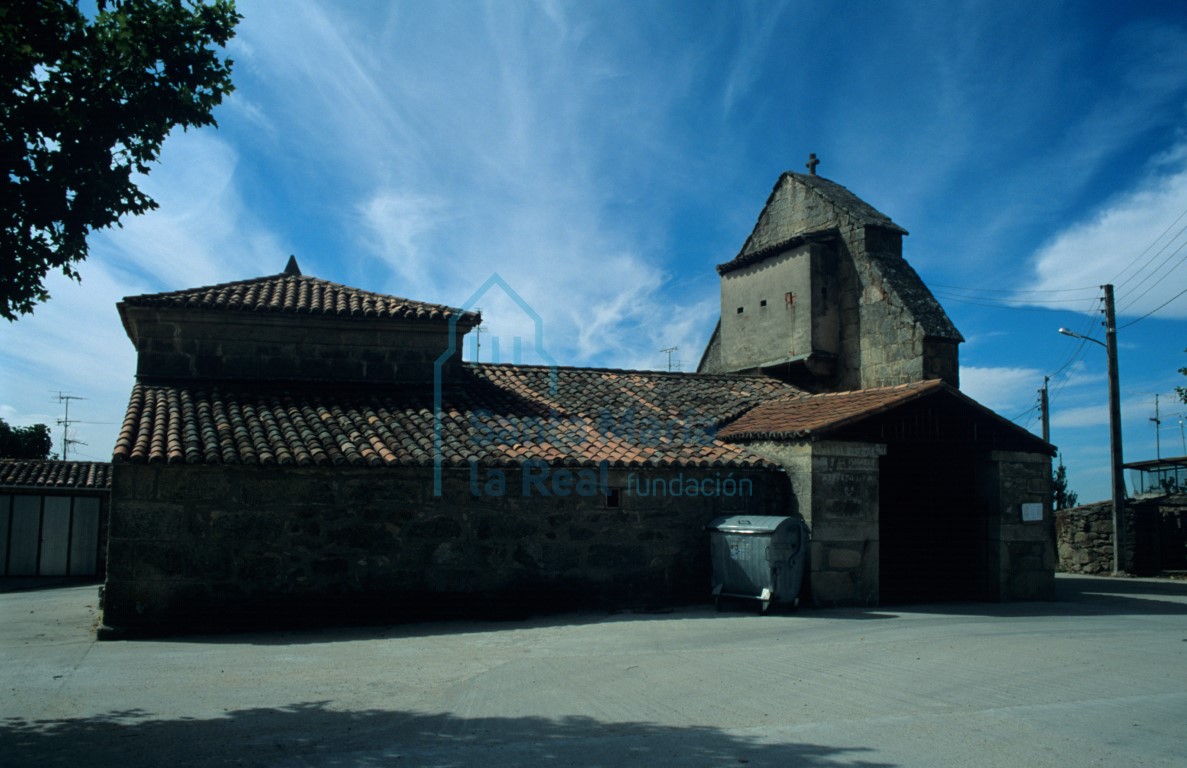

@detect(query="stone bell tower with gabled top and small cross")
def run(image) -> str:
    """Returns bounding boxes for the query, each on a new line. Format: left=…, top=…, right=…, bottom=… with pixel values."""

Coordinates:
left=697, top=162, right=964, bottom=392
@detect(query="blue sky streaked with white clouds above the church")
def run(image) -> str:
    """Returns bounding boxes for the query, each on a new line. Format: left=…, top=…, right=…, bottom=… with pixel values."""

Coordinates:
left=0, top=0, right=1187, bottom=501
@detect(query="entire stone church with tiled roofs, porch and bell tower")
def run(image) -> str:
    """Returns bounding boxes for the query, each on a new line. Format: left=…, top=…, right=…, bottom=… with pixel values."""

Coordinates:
left=103, top=173, right=1054, bottom=634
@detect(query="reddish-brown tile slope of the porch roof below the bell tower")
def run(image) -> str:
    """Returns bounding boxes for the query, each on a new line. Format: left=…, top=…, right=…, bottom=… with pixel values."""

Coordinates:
left=718, top=380, right=944, bottom=440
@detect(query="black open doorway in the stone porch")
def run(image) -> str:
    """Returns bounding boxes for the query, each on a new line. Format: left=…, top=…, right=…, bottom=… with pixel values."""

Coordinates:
left=878, top=443, right=989, bottom=604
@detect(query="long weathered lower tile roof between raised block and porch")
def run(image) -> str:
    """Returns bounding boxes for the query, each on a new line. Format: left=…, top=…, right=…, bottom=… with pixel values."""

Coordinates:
left=114, top=364, right=795, bottom=466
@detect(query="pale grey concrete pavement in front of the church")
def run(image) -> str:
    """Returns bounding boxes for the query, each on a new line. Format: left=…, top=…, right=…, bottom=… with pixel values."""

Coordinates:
left=0, top=576, right=1187, bottom=767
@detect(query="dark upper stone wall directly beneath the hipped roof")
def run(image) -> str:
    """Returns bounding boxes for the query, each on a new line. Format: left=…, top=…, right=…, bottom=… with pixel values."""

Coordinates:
left=120, top=307, right=465, bottom=383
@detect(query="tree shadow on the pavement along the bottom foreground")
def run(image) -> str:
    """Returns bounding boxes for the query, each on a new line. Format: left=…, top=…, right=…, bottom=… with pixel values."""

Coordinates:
left=0, top=702, right=889, bottom=768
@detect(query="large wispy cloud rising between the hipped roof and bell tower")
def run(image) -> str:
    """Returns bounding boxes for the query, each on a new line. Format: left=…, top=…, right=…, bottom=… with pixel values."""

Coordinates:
left=256, top=5, right=731, bottom=367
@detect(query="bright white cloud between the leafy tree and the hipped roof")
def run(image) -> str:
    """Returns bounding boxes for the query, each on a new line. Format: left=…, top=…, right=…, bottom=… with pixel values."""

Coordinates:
left=0, top=131, right=285, bottom=461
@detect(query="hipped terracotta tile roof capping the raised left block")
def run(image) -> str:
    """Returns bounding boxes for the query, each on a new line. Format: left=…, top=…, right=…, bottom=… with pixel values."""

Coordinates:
left=121, top=272, right=478, bottom=322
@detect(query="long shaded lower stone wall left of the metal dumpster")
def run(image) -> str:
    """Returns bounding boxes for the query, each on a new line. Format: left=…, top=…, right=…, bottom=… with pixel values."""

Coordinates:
left=104, top=464, right=788, bottom=630
